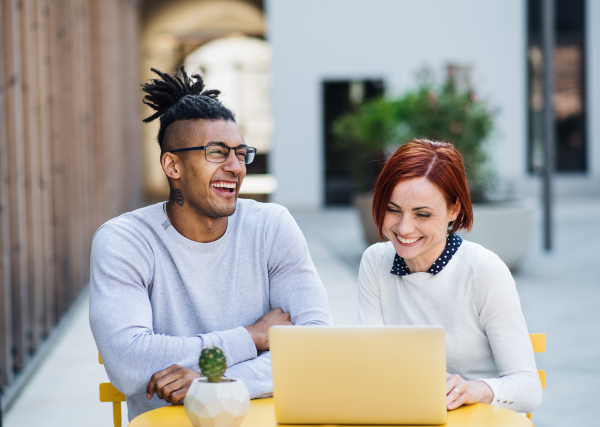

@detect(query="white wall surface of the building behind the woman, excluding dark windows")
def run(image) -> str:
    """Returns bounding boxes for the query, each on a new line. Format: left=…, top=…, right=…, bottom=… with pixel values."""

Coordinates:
left=265, top=0, right=600, bottom=208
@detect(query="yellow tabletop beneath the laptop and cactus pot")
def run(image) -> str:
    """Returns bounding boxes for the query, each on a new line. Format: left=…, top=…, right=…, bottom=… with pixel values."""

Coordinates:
left=129, top=398, right=533, bottom=427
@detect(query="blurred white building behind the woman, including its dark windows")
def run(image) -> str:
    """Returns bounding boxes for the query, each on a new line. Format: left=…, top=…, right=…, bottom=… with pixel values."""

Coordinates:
left=266, top=0, right=600, bottom=208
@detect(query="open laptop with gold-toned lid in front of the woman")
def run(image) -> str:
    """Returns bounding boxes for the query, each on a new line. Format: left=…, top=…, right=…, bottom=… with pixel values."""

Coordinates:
left=269, top=326, right=446, bottom=425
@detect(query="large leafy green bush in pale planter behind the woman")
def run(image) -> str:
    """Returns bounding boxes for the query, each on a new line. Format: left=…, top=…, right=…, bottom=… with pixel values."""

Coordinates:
left=333, top=65, right=533, bottom=269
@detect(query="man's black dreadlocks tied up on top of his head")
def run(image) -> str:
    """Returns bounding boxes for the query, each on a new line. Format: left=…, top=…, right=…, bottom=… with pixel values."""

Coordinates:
left=142, top=65, right=235, bottom=155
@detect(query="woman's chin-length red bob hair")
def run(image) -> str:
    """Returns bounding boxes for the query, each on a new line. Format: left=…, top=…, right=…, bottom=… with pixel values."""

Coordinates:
left=373, top=139, right=473, bottom=240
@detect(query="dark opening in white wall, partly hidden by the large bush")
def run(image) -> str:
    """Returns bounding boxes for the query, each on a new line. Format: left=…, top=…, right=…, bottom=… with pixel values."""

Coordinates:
left=323, top=80, right=383, bottom=206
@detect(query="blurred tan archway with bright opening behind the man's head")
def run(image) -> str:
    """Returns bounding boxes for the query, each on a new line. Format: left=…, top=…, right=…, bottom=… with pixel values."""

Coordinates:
left=140, top=0, right=276, bottom=201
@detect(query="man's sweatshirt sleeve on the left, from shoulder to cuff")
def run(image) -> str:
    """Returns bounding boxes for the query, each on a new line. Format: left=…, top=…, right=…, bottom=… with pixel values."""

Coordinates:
left=90, top=225, right=257, bottom=396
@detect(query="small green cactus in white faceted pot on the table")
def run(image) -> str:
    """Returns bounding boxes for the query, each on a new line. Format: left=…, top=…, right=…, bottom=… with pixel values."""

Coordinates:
left=183, top=347, right=250, bottom=427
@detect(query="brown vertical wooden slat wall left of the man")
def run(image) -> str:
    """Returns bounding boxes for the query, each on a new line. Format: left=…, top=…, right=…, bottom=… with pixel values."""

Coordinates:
left=0, top=0, right=141, bottom=387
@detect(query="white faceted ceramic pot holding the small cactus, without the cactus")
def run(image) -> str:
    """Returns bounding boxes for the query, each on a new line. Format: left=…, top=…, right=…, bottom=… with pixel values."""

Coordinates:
left=183, top=378, right=250, bottom=427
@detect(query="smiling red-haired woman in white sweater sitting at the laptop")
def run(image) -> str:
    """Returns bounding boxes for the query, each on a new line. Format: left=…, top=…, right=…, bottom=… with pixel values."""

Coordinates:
left=358, top=140, right=542, bottom=412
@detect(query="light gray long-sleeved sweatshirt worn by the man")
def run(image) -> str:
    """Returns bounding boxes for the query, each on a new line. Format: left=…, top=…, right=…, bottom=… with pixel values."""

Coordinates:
left=90, top=199, right=331, bottom=419
